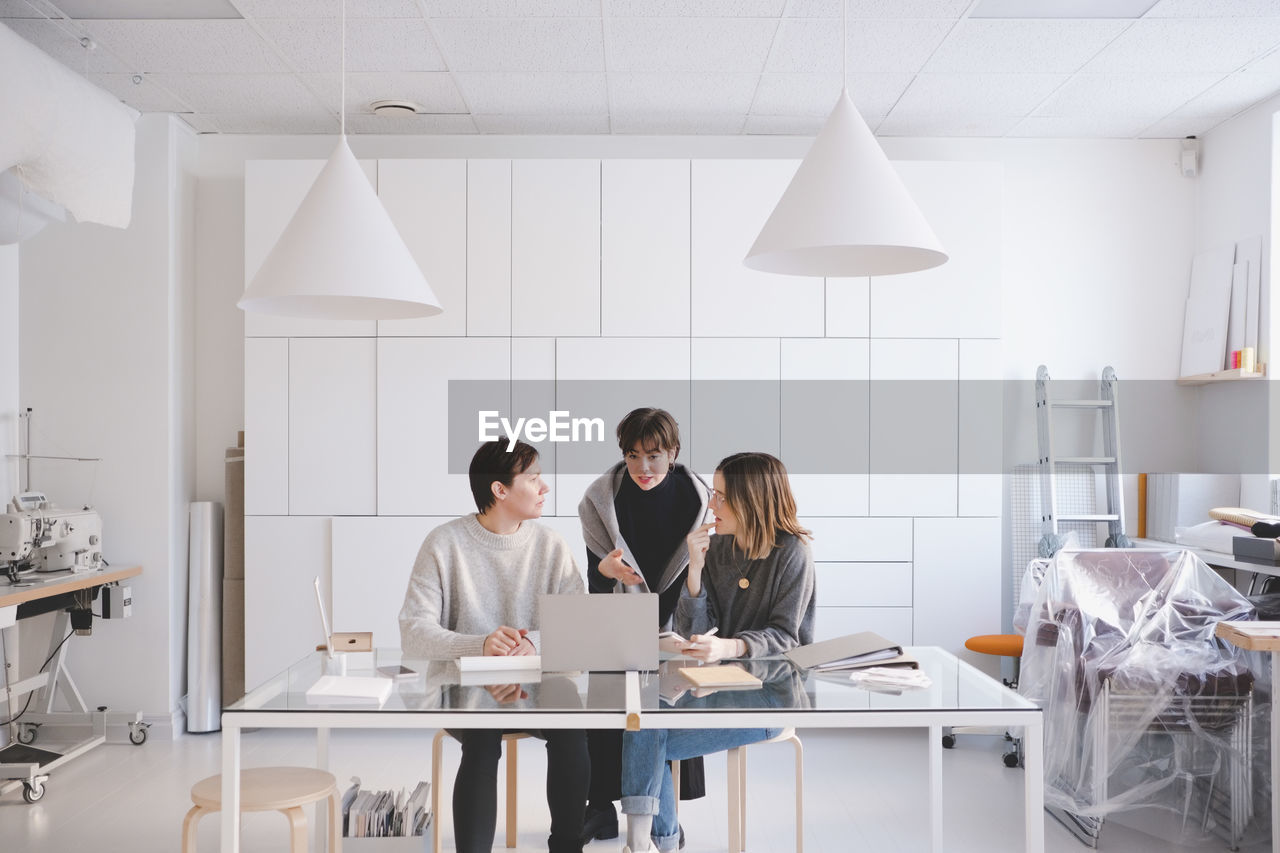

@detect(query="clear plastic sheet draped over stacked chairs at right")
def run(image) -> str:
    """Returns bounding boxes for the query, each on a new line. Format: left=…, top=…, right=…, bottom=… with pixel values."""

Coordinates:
left=1019, top=549, right=1270, bottom=843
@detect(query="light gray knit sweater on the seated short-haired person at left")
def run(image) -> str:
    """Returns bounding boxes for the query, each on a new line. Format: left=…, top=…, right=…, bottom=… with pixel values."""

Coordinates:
left=399, top=514, right=586, bottom=660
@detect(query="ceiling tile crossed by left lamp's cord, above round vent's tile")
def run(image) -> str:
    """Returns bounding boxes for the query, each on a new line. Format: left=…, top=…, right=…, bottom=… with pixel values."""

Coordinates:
left=257, top=18, right=445, bottom=73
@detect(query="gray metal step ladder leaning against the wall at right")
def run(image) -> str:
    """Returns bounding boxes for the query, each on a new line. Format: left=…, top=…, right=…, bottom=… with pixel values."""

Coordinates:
left=1036, top=365, right=1134, bottom=557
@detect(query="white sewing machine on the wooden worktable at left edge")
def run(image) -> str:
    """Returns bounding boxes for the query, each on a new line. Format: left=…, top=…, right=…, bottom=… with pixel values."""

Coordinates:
left=0, top=492, right=102, bottom=583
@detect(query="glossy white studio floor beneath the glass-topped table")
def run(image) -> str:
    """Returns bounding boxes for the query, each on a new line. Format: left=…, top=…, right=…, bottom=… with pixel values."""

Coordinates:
left=0, top=730, right=1270, bottom=853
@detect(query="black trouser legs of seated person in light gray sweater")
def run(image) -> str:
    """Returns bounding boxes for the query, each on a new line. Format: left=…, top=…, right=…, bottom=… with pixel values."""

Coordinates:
left=449, top=729, right=591, bottom=853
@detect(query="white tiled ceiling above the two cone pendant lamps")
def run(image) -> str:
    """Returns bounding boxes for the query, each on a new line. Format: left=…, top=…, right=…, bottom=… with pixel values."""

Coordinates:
left=0, top=0, right=1280, bottom=138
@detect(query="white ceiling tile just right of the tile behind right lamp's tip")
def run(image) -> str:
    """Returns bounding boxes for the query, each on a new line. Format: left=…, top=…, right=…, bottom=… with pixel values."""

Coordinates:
left=890, top=74, right=1068, bottom=119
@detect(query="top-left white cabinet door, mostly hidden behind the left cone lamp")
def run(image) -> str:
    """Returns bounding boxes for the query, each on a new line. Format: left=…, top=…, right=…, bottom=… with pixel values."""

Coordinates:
left=244, top=160, right=378, bottom=338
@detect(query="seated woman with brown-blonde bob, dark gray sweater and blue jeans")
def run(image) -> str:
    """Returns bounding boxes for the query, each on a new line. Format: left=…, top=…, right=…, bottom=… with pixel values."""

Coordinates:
left=622, top=453, right=814, bottom=853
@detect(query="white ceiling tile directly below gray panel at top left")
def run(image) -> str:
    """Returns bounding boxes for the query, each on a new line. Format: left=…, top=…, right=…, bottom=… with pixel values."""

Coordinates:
left=84, top=20, right=288, bottom=73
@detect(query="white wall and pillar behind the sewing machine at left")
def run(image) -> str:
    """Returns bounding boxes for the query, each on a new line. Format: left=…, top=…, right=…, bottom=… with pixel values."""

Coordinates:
left=18, top=115, right=195, bottom=720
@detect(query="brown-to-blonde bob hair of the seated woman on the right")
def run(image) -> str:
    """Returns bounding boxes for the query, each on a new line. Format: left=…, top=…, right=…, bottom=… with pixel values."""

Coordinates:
left=716, top=453, right=813, bottom=560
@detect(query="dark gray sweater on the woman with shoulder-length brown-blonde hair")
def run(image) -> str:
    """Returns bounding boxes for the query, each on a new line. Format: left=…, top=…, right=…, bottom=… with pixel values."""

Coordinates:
left=673, top=533, right=815, bottom=657
